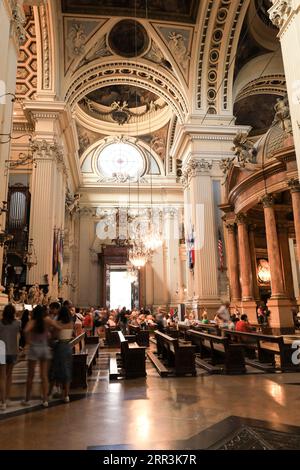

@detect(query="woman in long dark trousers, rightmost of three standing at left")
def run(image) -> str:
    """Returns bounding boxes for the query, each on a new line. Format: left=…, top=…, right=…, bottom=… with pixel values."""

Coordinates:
left=53, top=307, right=74, bottom=403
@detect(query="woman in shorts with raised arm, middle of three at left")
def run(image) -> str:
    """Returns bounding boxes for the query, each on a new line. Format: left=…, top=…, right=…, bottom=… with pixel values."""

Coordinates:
left=22, top=305, right=61, bottom=407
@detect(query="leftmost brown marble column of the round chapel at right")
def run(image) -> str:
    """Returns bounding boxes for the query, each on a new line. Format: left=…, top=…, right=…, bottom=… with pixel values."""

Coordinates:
left=226, top=223, right=241, bottom=304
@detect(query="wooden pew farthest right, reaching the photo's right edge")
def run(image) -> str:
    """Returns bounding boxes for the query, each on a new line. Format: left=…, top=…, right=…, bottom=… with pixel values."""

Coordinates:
left=224, top=330, right=300, bottom=372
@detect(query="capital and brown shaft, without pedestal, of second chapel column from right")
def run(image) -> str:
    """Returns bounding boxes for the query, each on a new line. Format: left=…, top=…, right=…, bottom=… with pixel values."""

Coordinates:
left=262, top=195, right=285, bottom=299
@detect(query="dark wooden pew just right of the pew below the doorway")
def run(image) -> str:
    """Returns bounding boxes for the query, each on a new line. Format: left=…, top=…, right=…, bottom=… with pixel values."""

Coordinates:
left=148, top=330, right=196, bottom=377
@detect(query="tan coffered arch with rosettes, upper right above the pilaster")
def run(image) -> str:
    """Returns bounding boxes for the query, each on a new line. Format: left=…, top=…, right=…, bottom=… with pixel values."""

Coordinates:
left=196, top=0, right=250, bottom=115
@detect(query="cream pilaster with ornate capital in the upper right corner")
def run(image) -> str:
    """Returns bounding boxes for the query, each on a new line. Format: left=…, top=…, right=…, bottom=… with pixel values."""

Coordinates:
left=269, top=0, right=300, bottom=169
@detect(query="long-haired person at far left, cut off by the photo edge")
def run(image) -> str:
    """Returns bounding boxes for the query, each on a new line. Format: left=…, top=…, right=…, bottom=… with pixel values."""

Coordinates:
left=0, top=304, right=21, bottom=411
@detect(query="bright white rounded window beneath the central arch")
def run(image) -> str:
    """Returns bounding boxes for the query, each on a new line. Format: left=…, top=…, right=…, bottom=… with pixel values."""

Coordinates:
left=98, top=142, right=144, bottom=178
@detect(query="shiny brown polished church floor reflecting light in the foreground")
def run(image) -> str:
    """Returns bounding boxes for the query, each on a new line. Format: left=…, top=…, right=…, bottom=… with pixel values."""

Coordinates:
left=0, top=350, right=300, bottom=449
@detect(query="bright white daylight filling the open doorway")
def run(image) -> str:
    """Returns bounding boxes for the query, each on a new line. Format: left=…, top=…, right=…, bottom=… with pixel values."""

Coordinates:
left=110, top=271, right=131, bottom=310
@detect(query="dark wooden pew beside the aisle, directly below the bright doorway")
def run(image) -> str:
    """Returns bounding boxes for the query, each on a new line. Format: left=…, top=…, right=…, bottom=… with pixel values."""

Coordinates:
left=109, top=331, right=147, bottom=380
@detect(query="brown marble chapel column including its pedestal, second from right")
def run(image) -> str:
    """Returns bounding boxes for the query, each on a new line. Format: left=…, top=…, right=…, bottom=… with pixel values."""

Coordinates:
left=262, top=194, right=293, bottom=332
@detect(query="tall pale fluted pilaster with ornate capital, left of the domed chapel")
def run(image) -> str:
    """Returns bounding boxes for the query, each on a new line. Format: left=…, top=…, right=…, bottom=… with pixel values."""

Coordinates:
left=185, top=158, right=220, bottom=312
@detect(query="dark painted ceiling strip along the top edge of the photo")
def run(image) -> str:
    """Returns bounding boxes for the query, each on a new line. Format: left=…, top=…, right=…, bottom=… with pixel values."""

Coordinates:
left=62, top=0, right=200, bottom=23
